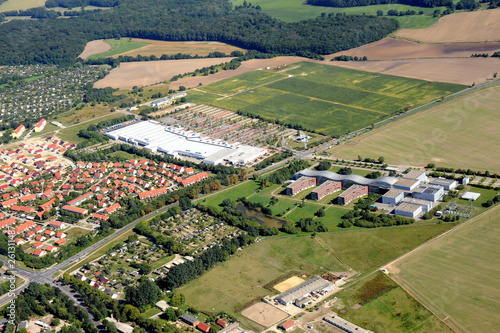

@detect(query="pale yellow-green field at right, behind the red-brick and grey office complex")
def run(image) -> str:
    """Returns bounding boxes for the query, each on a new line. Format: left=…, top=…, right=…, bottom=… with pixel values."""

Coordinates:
left=330, top=85, right=500, bottom=172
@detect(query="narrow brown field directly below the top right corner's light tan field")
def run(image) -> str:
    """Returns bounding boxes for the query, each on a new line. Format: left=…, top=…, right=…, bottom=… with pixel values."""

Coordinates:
left=325, top=37, right=500, bottom=60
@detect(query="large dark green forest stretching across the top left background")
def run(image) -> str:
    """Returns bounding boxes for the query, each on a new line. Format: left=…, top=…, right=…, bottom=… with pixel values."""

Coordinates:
left=0, top=0, right=398, bottom=65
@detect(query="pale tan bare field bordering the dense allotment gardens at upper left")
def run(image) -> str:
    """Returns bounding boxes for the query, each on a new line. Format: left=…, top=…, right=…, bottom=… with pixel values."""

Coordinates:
left=94, top=58, right=233, bottom=89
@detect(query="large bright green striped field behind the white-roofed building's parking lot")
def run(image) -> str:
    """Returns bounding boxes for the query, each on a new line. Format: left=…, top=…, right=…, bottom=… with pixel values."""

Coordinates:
left=189, top=62, right=464, bottom=136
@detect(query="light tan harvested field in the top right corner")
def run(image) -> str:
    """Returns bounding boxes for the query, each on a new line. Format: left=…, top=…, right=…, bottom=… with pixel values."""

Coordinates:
left=395, top=8, right=500, bottom=43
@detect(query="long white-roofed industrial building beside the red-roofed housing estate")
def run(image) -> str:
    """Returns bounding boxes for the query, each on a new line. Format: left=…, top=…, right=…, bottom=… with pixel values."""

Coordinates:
left=105, top=120, right=267, bottom=166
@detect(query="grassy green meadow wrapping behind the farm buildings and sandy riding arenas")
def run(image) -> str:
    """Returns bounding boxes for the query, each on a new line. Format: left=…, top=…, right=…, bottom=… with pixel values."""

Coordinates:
left=180, top=224, right=452, bottom=320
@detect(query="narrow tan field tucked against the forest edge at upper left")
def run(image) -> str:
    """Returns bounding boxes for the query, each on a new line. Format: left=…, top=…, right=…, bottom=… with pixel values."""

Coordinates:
left=113, top=38, right=245, bottom=58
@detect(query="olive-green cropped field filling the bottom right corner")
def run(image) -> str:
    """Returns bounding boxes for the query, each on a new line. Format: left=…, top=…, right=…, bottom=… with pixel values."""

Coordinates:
left=389, top=206, right=500, bottom=333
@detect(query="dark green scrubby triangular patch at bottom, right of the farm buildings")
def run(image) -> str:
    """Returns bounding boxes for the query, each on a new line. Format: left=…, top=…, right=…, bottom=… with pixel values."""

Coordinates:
left=335, top=272, right=452, bottom=333
